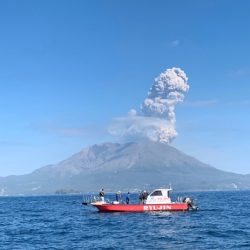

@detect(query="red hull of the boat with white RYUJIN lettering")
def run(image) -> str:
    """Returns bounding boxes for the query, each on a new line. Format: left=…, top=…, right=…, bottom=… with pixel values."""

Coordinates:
left=92, top=203, right=189, bottom=212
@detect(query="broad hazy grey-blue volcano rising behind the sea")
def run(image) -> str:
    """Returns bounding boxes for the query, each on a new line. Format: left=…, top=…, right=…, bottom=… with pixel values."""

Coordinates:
left=0, top=141, right=250, bottom=194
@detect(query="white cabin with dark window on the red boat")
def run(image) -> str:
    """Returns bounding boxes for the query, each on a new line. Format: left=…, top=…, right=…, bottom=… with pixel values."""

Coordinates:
left=146, top=188, right=172, bottom=204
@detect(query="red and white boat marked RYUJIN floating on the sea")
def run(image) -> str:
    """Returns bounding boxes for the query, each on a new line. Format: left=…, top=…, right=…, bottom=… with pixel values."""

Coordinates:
left=82, top=187, right=198, bottom=212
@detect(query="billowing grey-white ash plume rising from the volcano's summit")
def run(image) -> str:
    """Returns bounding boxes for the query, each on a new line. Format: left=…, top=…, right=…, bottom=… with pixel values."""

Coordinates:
left=109, top=68, right=189, bottom=143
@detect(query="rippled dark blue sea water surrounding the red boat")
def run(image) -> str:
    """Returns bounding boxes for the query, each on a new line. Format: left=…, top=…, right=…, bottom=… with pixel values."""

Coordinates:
left=0, top=191, right=250, bottom=250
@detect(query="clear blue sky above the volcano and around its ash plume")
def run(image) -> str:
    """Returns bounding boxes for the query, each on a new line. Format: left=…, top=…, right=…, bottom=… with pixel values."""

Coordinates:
left=0, top=0, right=250, bottom=176
